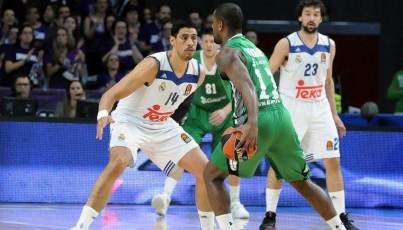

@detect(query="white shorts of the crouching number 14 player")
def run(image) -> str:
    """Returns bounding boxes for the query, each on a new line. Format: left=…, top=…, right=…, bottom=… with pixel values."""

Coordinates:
left=109, top=112, right=198, bottom=175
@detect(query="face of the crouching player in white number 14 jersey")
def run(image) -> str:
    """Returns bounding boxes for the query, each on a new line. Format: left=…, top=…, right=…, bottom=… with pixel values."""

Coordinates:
left=170, top=28, right=197, bottom=61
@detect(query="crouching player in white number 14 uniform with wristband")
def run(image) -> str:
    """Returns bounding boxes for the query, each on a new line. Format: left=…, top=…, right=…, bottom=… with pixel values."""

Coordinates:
left=73, top=21, right=214, bottom=230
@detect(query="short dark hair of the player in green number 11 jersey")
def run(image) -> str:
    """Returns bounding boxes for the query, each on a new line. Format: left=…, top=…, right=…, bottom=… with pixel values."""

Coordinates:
left=214, top=3, right=243, bottom=32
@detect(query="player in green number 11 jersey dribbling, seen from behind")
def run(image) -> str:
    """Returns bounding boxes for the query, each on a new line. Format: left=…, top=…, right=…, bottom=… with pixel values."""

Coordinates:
left=203, top=3, right=345, bottom=230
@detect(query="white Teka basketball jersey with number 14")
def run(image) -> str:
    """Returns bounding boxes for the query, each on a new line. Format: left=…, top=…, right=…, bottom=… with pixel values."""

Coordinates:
left=116, top=52, right=200, bottom=122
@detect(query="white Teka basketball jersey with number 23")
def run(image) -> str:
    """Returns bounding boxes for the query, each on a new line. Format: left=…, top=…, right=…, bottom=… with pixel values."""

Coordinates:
left=279, top=32, right=330, bottom=101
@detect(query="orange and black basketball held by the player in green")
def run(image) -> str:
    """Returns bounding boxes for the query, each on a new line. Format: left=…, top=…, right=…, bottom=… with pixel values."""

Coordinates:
left=221, top=127, right=256, bottom=161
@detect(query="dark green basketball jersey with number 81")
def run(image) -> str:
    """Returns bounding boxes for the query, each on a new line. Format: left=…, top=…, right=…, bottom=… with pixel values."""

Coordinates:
left=192, top=50, right=231, bottom=112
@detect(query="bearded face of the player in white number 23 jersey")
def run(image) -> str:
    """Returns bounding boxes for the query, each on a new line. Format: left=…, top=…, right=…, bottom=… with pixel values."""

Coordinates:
left=298, top=6, right=322, bottom=34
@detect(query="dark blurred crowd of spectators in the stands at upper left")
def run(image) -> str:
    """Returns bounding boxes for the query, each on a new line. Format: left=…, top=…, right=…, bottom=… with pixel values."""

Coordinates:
left=0, top=0, right=212, bottom=90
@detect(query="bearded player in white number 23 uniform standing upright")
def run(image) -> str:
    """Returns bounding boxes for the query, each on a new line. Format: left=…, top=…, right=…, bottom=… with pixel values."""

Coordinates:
left=260, top=0, right=358, bottom=230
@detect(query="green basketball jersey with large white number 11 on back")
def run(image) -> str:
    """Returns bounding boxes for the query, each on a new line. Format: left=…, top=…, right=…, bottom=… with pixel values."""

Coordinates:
left=225, top=34, right=281, bottom=125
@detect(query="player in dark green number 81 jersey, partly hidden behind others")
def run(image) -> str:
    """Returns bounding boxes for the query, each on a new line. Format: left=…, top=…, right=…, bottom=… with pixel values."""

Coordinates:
left=151, top=28, right=249, bottom=219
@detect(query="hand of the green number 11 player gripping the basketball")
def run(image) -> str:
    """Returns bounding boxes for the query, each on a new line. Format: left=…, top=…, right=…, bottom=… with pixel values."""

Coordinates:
left=234, top=122, right=258, bottom=157
